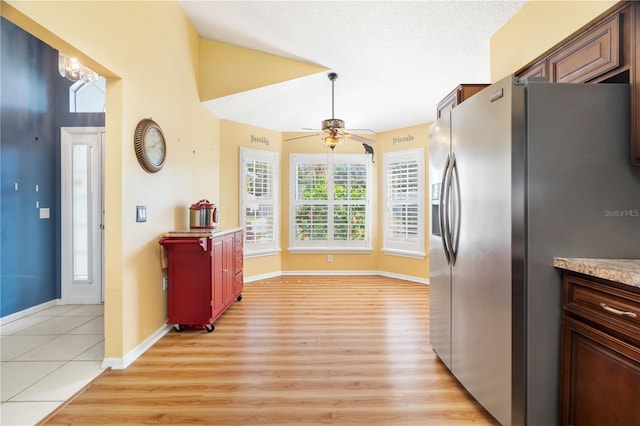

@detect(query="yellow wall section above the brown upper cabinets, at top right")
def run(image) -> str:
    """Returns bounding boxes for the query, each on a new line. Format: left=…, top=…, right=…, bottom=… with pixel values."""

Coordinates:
left=490, top=0, right=618, bottom=82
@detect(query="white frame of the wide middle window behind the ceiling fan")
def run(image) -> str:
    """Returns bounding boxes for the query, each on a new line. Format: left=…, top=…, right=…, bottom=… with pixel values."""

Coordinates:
left=288, top=153, right=373, bottom=253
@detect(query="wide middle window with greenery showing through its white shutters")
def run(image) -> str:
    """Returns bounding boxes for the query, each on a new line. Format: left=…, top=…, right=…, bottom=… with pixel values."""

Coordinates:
left=289, top=153, right=371, bottom=252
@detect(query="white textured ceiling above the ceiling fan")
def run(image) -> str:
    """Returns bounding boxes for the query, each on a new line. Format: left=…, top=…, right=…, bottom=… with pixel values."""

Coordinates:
left=179, top=0, right=526, bottom=132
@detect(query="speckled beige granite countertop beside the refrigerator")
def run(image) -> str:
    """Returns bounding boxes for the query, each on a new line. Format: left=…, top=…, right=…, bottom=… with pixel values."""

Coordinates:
left=553, top=257, right=640, bottom=288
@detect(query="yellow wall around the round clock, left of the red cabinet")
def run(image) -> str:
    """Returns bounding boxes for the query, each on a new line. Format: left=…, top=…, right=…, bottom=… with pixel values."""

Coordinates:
left=2, top=0, right=220, bottom=359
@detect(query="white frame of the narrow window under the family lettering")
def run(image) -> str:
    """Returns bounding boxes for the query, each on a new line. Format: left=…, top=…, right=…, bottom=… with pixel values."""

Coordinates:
left=239, top=147, right=280, bottom=258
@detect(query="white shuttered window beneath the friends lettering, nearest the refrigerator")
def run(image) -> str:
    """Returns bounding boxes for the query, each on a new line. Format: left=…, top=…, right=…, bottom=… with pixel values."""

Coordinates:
left=382, top=148, right=425, bottom=258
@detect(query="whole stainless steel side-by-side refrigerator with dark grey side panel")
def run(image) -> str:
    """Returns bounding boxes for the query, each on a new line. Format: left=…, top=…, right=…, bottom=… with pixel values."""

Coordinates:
left=429, top=76, right=640, bottom=426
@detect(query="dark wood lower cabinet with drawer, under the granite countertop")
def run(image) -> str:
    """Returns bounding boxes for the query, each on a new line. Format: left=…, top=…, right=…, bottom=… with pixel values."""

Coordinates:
left=561, top=273, right=640, bottom=426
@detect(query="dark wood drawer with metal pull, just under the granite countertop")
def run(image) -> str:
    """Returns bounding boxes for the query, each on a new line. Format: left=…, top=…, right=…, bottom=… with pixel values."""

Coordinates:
left=563, top=274, right=640, bottom=342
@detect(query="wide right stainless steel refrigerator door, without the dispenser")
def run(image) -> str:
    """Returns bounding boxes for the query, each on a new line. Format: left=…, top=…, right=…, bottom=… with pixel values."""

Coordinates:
left=451, top=79, right=513, bottom=425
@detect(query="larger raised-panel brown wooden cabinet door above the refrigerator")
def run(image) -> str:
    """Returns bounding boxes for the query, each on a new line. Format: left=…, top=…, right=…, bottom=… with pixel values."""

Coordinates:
left=549, top=14, right=620, bottom=83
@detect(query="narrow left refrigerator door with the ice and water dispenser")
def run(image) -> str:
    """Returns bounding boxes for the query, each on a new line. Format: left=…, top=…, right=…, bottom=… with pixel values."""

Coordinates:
left=429, top=113, right=451, bottom=369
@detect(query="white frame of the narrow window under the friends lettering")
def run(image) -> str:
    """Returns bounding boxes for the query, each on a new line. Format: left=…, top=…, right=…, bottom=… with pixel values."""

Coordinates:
left=382, top=148, right=426, bottom=259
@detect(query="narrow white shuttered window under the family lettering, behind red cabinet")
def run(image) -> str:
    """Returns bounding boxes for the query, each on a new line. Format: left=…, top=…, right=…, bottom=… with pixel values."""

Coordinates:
left=240, top=148, right=280, bottom=256
